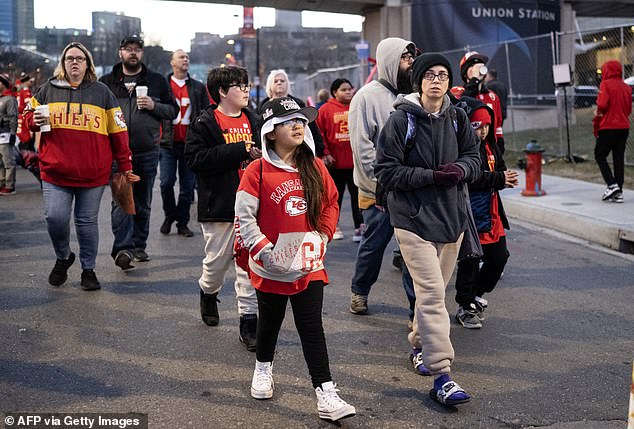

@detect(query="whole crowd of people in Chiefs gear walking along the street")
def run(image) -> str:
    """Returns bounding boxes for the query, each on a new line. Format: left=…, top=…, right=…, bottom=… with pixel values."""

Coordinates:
left=0, top=31, right=631, bottom=421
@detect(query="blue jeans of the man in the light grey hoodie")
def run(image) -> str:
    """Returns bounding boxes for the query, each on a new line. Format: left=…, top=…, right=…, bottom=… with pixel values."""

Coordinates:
left=351, top=206, right=416, bottom=320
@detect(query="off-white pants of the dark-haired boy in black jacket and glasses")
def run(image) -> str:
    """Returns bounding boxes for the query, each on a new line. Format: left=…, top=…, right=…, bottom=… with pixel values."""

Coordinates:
left=198, top=222, right=258, bottom=316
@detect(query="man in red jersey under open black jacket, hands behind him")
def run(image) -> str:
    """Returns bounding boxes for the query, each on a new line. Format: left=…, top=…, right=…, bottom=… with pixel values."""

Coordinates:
left=159, top=49, right=209, bottom=237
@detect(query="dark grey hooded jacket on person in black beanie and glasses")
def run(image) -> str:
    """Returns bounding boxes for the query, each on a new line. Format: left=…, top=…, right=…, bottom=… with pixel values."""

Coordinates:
left=374, top=94, right=480, bottom=243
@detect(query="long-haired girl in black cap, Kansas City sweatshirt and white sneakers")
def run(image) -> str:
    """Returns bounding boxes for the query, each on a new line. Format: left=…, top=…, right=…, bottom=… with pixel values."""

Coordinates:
left=235, top=97, right=356, bottom=421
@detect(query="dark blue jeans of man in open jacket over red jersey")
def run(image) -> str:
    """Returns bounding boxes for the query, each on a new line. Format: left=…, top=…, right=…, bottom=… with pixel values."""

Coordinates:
left=159, top=142, right=196, bottom=226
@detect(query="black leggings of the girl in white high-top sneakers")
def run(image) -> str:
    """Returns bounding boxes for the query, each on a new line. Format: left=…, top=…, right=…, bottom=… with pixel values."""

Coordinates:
left=255, top=281, right=332, bottom=388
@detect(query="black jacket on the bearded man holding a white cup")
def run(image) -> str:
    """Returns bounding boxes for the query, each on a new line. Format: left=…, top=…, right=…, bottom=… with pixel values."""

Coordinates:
left=99, top=63, right=178, bottom=155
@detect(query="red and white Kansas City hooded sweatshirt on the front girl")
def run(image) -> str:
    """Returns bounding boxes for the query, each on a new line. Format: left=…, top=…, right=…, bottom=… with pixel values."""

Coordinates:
left=235, top=122, right=339, bottom=295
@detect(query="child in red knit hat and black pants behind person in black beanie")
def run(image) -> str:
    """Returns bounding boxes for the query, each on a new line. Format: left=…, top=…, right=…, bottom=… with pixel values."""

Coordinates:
left=456, top=96, right=518, bottom=329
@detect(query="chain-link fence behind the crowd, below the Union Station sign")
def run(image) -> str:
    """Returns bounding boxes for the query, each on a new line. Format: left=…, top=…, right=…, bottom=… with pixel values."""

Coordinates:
left=303, top=21, right=634, bottom=165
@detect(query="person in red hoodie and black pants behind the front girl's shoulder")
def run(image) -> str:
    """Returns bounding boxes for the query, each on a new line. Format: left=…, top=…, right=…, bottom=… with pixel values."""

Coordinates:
left=316, top=79, right=363, bottom=242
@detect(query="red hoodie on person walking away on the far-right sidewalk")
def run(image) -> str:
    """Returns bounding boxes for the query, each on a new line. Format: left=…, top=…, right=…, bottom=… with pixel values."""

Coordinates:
left=593, top=60, right=632, bottom=130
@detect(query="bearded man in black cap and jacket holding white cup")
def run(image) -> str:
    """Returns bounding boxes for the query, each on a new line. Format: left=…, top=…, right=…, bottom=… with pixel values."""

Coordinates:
left=100, top=36, right=178, bottom=270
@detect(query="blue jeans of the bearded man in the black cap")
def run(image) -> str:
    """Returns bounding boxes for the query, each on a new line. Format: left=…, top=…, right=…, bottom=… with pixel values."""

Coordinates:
left=110, top=150, right=159, bottom=258
